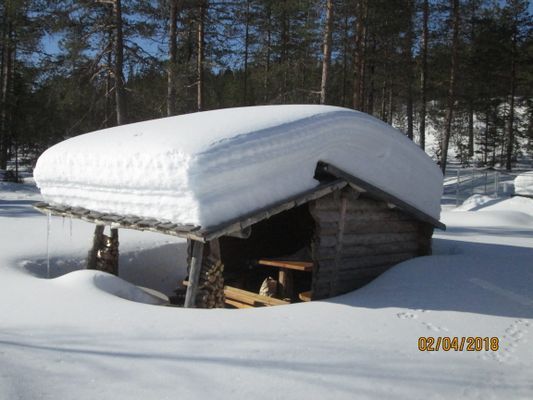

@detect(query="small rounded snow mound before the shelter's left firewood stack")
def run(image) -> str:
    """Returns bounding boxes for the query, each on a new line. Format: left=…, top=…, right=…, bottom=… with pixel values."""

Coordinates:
left=54, top=270, right=168, bottom=305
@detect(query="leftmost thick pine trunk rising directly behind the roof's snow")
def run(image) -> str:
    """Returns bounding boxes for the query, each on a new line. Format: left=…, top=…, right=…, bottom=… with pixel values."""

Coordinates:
left=113, top=0, right=126, bottom=125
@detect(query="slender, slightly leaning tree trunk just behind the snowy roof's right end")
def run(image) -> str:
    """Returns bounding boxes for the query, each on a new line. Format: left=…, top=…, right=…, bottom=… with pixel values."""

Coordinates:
left=440, top=0, right=459, bottom=174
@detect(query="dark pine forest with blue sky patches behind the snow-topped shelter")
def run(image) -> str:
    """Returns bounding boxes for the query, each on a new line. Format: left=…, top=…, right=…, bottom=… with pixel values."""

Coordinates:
left=0, top=0, right=533, bottom=178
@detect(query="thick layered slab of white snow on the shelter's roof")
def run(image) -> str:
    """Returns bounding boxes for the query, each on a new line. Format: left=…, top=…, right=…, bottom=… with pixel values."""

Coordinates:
left=34, top=105, right=442, bottom=227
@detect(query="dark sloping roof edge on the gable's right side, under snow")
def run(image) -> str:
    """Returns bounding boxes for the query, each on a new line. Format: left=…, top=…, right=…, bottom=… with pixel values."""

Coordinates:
left=315, top=161, right=446, bottom=230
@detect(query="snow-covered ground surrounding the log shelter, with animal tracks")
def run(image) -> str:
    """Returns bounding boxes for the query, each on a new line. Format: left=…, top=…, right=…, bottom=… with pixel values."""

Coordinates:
left=0, top=183, right=533, bottom=400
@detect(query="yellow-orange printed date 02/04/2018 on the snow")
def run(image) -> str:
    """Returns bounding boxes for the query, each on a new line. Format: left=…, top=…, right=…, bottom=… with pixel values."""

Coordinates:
left=418, top=336, right=500, bottom=351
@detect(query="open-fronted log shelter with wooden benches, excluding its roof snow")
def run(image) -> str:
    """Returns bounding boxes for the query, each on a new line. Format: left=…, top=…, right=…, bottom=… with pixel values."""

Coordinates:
left=34, top=162, right=446, bottom=308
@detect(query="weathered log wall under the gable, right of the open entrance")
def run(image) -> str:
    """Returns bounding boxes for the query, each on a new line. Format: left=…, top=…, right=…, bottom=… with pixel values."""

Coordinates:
left=309, top=187, right=433, bottom=299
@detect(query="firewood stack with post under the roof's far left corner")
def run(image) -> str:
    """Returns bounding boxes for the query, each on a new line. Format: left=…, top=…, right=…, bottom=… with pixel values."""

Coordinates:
left=87, top=225, right=119, bottom=275
